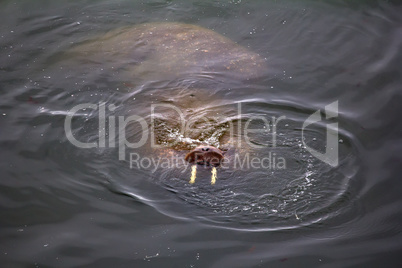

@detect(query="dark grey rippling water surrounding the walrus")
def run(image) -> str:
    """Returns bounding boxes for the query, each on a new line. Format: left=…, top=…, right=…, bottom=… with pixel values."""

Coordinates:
left=0, top=1, right=402, bottom=267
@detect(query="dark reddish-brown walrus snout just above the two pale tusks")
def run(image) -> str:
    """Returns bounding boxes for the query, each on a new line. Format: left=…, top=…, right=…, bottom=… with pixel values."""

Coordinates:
left=185, top=146, right=224, bottom=167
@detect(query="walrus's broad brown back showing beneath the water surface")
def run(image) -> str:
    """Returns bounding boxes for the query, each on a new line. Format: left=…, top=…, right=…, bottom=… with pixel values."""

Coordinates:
left=69, top=23, right=265, bottom=80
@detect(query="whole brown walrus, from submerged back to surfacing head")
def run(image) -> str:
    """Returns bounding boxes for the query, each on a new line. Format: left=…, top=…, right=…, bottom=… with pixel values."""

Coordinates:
left=69, top=22, right=267, bottom=183
